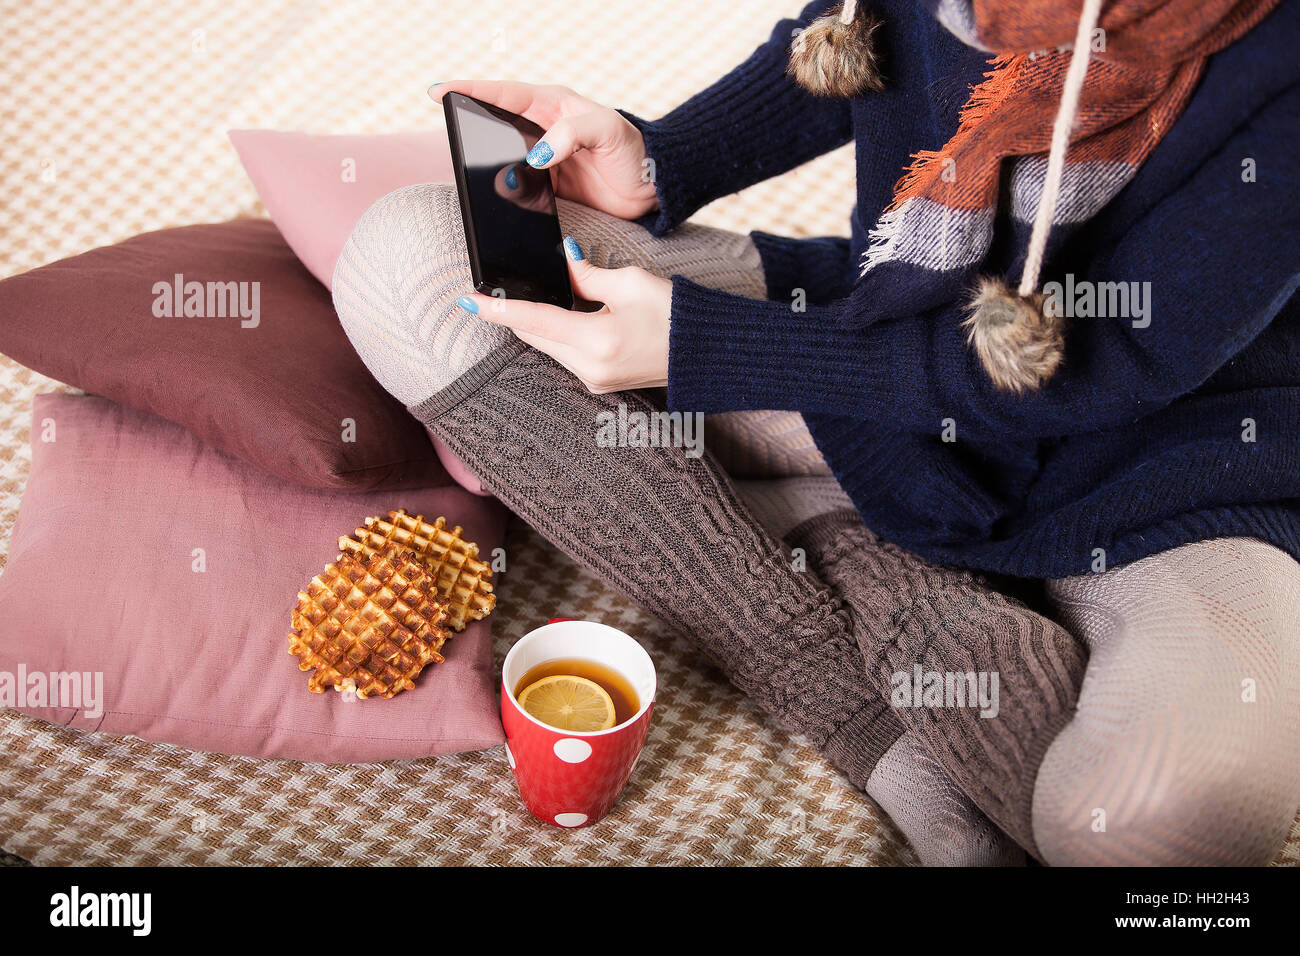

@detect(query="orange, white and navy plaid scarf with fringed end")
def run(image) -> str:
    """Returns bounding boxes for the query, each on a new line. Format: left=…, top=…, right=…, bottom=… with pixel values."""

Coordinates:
left=790, top=0, right=1281, bottom=392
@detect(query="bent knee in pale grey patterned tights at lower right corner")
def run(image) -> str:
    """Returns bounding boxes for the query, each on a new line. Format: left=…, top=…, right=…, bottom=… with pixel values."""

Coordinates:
left=1034, top=538, right=1300, bottom=865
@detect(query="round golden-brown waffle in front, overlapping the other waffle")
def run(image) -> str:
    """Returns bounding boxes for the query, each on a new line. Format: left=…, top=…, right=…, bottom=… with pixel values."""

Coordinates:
left=289, top=545, right=447, bottom=700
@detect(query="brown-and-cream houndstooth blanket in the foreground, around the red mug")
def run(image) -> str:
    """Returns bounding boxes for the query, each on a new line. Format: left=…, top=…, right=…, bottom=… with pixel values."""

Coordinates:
left=0, top=522, right=914, bottom=865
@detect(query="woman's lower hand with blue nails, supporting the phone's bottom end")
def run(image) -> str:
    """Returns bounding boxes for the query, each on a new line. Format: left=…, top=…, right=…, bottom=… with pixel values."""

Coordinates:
left=458, top=237, right=672, bottom=394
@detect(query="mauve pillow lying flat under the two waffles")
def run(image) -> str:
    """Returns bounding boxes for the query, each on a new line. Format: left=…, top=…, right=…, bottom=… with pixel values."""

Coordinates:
left=0, top=394, right=504, bottom=762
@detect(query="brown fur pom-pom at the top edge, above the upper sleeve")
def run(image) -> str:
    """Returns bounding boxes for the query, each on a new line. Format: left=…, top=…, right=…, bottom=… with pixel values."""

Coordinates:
left=785, top=0, right=885, bottom=98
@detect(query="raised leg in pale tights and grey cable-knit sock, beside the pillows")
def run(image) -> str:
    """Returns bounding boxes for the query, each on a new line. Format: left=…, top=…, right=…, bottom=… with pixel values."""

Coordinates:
left=333, top=185, right=901, bottom=787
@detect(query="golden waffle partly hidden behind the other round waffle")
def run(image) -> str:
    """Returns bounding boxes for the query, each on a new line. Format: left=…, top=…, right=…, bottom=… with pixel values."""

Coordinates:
left=338, top=510, right=497, bottom=631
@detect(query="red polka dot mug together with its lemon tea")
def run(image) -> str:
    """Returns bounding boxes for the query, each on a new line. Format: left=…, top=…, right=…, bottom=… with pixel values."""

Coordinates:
left=501, top=618, right=655, bottom=827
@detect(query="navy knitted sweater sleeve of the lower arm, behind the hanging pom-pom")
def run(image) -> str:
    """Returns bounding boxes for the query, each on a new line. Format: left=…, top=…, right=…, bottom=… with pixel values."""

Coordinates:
left=668, top=86, right=1300, bottom=440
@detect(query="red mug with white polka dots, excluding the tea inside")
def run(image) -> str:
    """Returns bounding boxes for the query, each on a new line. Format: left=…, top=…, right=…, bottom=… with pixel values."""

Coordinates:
left=501, top=618, right=655, bottom=827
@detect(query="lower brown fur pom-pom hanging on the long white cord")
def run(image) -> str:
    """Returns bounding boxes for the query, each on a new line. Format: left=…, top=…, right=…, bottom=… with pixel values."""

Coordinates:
left=962, top=278, right=1065, bottom=394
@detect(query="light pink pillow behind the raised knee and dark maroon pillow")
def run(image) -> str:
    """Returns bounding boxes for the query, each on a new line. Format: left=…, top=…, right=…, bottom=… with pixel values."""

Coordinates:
left=228, top=130, right=490, bottom=496
